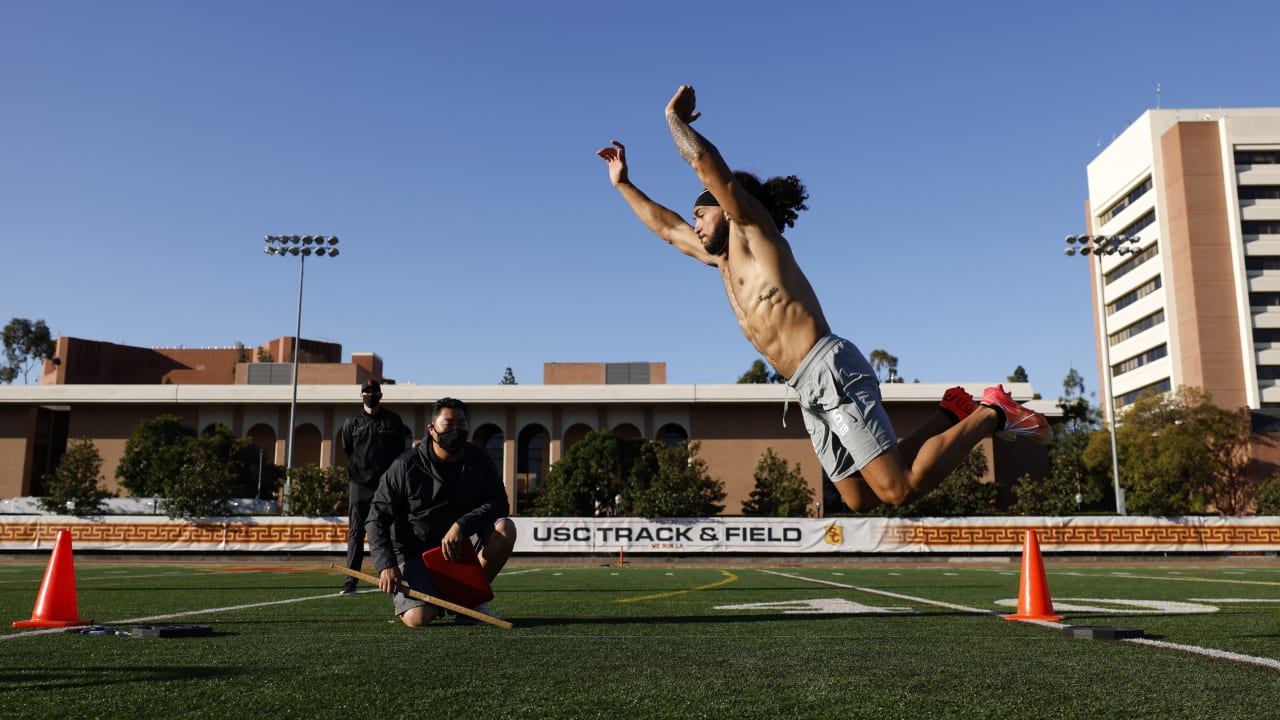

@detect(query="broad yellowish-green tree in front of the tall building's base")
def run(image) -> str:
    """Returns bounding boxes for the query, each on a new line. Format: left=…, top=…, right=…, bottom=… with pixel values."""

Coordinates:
left=1116, top=387, right=1256, bottom=515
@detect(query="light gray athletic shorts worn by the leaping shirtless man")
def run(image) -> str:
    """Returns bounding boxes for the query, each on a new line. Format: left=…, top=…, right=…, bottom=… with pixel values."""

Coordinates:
left=787, top=334, right=897, bottom=482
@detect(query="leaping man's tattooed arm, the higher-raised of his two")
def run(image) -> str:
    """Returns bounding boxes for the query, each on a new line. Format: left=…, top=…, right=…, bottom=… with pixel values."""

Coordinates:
left=667, top=85, right=772, bottom=227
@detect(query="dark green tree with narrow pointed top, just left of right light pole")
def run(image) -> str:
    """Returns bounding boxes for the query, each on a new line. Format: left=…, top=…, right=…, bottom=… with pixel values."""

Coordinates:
left=1010, top=368, right=1115, bottom=515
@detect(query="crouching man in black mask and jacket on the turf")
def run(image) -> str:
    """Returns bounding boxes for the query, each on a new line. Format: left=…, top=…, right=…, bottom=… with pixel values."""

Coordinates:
left=366, top=397, right=516, bottom=628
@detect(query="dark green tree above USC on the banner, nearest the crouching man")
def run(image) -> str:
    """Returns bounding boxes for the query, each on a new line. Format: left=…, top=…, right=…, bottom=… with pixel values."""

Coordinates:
left=532, top=429, right=637, bottom=518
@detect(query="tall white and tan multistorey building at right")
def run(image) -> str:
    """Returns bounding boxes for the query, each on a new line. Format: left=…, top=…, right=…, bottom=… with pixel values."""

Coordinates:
left=1087, top=108, right=1280, bottom=417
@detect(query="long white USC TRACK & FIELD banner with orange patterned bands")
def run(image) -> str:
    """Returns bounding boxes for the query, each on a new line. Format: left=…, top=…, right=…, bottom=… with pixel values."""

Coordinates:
left=0, top=515, right=1280, bottom=555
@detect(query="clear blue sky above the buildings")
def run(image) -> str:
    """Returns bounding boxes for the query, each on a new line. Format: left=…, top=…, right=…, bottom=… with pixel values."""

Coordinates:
left=0, top=0, right=1280, bottom=398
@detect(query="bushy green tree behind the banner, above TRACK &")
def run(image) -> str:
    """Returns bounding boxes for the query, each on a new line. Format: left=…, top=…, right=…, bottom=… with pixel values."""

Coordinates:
left=622, top=441, right=724, bottom=518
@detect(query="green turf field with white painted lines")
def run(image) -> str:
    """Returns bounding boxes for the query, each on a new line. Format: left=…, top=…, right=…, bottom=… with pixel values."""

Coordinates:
left=0, top=556, right=1280, bottom=720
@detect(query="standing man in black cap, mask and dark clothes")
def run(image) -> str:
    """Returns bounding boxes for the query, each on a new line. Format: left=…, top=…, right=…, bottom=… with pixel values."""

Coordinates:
left=342, top=380, right=413, bottom=594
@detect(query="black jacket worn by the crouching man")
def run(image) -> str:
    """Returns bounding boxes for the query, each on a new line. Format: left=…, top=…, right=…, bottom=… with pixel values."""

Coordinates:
left=365, top=439, right=511, bottom=573
